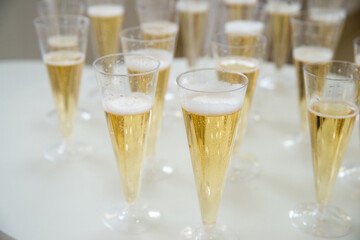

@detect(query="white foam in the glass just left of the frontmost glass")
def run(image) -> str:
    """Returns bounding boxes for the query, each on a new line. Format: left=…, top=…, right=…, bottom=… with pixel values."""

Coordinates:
left=102, top=93, right=153, bottom=115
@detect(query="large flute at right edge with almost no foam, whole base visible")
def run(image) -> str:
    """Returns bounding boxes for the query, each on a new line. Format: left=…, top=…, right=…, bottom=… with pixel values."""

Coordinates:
left=289, top=61, right=360, bottom=237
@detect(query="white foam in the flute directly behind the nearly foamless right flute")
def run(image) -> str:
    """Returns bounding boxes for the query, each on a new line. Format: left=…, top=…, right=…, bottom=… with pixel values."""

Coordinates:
left=294, top=46, right=333, bottom=62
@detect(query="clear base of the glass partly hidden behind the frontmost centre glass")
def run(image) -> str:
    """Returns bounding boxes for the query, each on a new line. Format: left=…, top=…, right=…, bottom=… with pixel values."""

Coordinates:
left=228, top=153, right=260, bottom=182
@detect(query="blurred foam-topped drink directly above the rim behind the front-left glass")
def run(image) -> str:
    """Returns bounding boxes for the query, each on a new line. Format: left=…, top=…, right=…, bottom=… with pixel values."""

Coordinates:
left=141, top=21, right=178, bottom=50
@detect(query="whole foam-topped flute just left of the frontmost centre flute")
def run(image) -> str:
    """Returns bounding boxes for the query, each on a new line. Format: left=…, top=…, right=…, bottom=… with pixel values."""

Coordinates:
left=93, top=54, right=160, bottom=233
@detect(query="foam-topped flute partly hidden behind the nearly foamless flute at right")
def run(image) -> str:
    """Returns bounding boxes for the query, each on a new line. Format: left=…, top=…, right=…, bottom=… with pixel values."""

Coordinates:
left=284, top=13, right=342, bottom=147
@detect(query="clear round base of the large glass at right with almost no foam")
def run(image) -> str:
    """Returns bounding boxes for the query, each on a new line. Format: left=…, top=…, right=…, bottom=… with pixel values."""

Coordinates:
left=289, top=203, right=351, bottom=238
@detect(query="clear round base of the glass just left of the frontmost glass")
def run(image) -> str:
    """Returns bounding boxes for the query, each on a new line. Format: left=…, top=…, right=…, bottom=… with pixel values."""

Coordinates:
left=103, top=206, right=161, bottom=234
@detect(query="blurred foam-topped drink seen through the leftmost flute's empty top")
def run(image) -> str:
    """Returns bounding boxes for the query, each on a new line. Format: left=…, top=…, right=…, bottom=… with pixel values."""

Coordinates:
left=48, top=35, right=78, bottom=52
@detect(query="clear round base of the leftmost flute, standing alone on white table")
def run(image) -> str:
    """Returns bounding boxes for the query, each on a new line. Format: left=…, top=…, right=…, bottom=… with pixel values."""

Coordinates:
left=44, top=143, right=93, bottom=162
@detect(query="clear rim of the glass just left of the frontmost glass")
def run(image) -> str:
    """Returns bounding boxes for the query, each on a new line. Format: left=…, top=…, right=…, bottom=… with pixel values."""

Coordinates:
left=92, top=53, right=160, bottom=77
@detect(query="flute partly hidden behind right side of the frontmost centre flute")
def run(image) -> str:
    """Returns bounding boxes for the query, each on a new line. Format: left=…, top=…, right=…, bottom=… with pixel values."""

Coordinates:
left=211, top=33, right=266, bottom=181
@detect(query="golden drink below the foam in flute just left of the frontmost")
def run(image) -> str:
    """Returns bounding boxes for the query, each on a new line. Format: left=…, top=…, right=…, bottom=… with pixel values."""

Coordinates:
left=105, top=102, right=150, bottom=203
